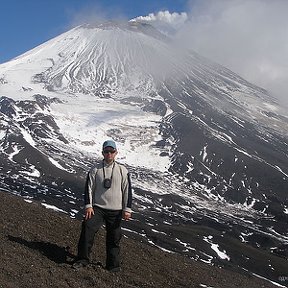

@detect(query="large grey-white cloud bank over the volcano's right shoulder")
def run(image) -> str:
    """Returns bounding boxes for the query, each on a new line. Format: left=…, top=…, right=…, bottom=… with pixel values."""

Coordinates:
left=175, top=0, right=288, bottom=103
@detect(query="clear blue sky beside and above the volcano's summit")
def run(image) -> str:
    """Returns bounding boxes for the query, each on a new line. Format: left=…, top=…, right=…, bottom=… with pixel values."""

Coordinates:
left=0, top=0, right=190, bottom=63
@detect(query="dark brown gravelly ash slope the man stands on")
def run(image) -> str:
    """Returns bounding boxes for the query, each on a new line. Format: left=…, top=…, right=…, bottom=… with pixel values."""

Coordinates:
left=0, top=192, right=275, bottom=288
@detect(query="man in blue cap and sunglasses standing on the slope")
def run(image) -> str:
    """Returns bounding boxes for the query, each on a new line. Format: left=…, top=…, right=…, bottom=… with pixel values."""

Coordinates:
left=73, top=140, right=132, bottom=272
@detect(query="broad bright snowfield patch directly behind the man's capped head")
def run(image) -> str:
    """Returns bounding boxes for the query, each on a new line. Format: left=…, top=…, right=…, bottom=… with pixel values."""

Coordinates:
left=51, top=95, right=170, bottom=172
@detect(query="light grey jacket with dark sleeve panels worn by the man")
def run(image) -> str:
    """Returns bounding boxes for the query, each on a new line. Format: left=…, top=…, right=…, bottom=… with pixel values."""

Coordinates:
left=84, top=161, right=132, bottom=212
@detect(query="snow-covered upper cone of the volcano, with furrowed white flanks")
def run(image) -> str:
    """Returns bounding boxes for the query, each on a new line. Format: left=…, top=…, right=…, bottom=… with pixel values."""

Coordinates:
left=1, top=22, right=178, bottom=97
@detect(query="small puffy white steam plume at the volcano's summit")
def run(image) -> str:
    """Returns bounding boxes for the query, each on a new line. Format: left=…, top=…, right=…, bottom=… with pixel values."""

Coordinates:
left=131, top=10, right=188, bottom=35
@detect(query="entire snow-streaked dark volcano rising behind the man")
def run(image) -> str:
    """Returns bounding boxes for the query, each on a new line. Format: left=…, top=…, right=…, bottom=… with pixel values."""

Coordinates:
left=0, top=21, right=288, bottom=280
